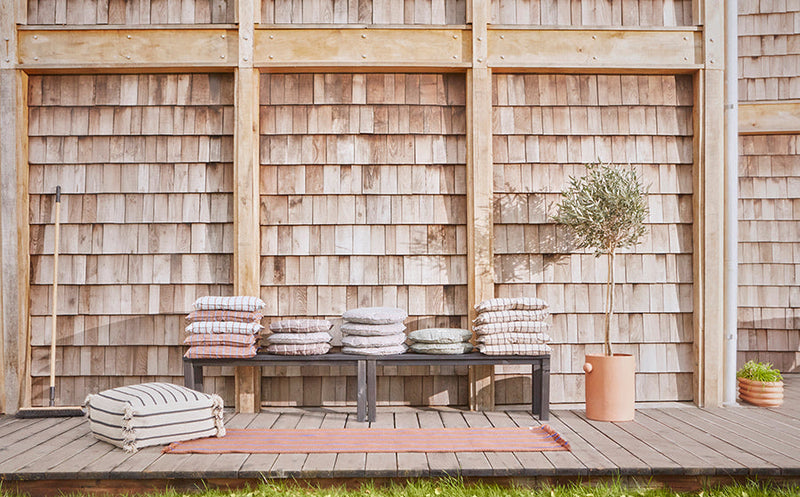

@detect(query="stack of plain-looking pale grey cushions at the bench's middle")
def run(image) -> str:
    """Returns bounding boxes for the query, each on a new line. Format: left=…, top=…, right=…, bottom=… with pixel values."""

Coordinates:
left=342, top=307, right=408, bottom=355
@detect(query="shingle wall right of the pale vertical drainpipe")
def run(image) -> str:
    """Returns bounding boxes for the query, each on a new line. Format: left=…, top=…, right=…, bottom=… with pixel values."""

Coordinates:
left=738, top=0, right=800, bottom=371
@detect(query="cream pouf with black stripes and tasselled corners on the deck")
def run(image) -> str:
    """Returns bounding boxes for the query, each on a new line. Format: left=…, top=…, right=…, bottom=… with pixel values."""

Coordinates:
left=85, top=383, right=225, bottom=452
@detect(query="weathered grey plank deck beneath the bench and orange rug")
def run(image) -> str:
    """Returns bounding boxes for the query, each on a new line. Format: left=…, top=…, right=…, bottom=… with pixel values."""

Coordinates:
left=0, top=375, right=800, bottom=495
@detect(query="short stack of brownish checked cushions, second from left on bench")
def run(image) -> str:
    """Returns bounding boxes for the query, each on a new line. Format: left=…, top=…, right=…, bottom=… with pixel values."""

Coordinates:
left=267, top=319, right=333, bottom=355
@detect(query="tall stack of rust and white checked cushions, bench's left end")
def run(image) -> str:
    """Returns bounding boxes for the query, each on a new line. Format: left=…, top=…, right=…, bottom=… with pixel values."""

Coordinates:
left=183, top=296, right=265, bottom=359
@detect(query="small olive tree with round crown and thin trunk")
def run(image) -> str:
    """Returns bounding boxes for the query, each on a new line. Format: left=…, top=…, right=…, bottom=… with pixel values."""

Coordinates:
left=553, top=161, right=648, bottom=355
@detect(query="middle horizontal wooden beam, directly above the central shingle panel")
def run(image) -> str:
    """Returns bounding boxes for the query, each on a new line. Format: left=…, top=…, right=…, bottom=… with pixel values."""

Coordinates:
left=255, top=28, right=471, bottom=68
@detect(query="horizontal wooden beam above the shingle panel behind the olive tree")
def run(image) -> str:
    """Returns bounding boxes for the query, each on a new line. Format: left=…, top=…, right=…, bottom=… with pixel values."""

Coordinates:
left=489, top=27, right=703, bottom=73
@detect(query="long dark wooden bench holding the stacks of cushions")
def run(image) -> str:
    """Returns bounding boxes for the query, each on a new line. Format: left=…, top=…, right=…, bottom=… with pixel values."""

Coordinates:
left=183, top=352, right=550, bottom=421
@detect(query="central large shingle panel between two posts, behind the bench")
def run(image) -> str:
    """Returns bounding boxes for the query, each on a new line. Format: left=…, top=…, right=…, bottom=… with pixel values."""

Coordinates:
left=260, top=74, right=467, bottom=405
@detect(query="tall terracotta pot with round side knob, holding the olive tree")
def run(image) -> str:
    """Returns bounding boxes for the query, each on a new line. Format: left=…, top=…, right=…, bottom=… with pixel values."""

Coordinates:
left=583, top=354, right=636, bottom=421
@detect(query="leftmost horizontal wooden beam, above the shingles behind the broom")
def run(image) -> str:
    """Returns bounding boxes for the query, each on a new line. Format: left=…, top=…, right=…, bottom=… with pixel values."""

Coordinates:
left=19, top=27, right=238, bottom=70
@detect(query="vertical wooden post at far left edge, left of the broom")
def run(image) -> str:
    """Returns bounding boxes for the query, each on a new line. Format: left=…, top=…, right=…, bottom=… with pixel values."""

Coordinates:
left=0, top=2, right=30, bottom=414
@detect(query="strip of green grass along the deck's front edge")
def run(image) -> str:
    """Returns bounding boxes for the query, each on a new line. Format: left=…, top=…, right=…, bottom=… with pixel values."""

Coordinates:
left=0, top=478, right=800, bottom=497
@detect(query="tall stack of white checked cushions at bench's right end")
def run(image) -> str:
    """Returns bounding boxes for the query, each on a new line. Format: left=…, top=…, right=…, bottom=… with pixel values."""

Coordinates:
left=473, top=297, right=550, bottom=355
